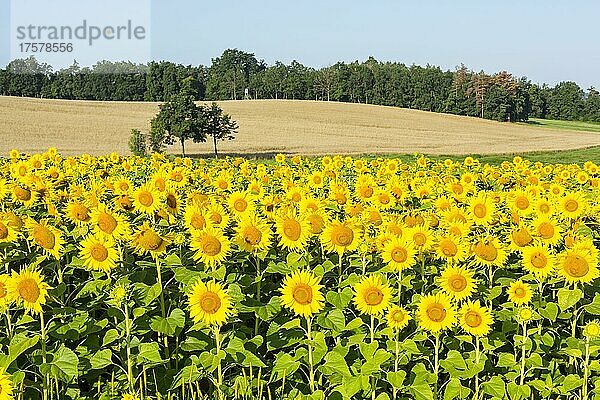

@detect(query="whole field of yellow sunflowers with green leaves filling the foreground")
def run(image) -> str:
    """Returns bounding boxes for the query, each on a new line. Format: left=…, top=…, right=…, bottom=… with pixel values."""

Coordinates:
left=0, top=149, right=600, bottom=400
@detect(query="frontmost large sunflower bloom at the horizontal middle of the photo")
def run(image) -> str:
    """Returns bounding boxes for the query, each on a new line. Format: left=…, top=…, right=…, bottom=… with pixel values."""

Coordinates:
left=280, top=271, right=325, bottom=318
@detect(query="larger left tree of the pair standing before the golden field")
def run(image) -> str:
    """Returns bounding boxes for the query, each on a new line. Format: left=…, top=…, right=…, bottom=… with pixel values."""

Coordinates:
left=150, top=94, right=206, bottom=157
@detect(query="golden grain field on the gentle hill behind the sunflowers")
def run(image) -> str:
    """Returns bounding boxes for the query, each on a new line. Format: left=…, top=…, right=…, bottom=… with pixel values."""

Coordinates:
left=0, top=97, right=600, bottom=155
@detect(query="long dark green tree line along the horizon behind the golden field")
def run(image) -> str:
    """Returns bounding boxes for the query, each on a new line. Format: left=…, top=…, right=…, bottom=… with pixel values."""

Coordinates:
left=0, top=49, right=600, bottom=122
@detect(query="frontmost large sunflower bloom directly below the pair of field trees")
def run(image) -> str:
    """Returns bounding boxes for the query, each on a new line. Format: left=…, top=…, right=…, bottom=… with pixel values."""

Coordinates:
left=188, top=281, right=234, bottom=326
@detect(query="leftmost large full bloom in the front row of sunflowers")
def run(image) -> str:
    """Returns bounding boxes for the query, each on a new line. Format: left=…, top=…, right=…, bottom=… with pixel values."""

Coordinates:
left=6, top=269, right=50, bottom=314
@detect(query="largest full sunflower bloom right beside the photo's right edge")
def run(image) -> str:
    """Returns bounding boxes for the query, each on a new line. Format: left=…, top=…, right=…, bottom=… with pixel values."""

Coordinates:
left=556, top=245, right=600, bottom=284
